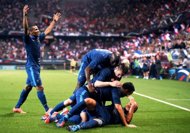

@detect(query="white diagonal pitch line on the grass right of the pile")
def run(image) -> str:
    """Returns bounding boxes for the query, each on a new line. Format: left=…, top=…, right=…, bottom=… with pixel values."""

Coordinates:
left=134, top=92, right=190, bottom=112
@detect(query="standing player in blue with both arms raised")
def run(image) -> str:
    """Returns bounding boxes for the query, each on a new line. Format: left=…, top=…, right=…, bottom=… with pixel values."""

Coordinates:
left=13, top=5, right=61, bottom=113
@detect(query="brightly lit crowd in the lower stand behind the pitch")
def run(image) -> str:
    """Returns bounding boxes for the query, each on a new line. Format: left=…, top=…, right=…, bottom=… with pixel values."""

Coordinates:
left=0, top=31, right=190, bottom=79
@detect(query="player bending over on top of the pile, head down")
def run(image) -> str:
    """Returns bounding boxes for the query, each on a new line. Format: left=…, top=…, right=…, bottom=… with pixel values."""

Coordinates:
left=76, top=49, right=120, bottom=89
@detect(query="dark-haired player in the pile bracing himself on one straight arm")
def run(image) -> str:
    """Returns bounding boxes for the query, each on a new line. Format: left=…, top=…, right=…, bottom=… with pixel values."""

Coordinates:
left=56, top=82, right=135, bottom=127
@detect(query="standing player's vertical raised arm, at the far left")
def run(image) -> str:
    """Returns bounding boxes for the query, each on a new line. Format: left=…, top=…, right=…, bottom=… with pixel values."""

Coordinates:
left=23, top=5, right=29, bottom=35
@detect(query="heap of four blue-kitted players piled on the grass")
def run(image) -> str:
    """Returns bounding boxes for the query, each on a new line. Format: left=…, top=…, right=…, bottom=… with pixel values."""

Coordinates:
left=43, top=49, right=137, bottom=131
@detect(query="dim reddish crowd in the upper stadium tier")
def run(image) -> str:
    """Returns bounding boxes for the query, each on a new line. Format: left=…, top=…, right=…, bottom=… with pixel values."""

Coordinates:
left=0, top=0, right=190, bottom=34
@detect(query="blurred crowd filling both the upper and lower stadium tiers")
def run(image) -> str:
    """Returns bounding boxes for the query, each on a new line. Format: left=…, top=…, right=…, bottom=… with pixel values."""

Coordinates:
left=0, top=0, right=190, bottom=79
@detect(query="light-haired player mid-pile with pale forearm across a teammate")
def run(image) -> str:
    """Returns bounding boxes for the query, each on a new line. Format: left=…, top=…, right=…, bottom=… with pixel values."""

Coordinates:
left=43, top=66, right=123, bottom=123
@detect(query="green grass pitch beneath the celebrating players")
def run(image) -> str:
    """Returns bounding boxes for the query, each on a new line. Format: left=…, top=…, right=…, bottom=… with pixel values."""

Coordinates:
left=0, top=70, right=190, bottom=133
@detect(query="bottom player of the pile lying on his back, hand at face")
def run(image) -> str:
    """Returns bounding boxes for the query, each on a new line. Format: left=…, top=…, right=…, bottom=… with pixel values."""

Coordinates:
left=66, top=96, right=138, bottom=132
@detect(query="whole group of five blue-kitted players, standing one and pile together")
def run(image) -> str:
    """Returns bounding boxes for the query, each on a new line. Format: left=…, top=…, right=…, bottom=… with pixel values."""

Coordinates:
left=13, top=5, right=138, bottom=131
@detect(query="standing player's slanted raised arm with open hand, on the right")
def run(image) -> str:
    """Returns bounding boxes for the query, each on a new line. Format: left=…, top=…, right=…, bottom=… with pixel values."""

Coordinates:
left=44, top=12, right=61, bottom=35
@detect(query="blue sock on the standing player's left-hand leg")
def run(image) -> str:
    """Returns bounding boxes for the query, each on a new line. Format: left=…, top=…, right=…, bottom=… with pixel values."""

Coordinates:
left=15, top=89, right=31, bottom=108
